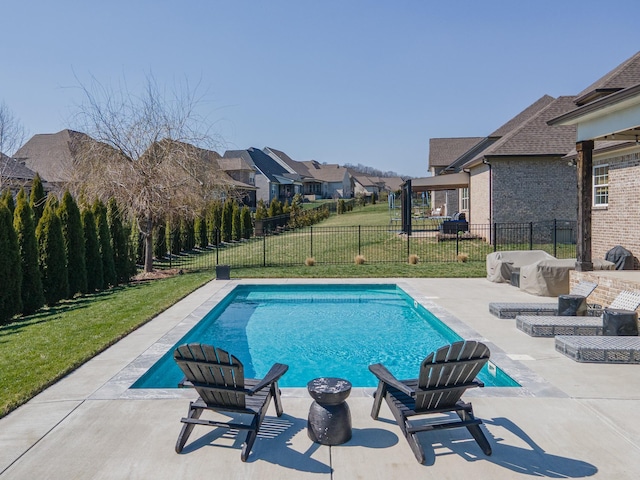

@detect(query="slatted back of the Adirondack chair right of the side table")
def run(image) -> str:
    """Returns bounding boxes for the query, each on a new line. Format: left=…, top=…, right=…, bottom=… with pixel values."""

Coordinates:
left=415, top=341, right=490, bottom=411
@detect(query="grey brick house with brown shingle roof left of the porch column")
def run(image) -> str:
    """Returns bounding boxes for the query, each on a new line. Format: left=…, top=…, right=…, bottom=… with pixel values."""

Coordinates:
left=412, top=95, right=576, bottom=228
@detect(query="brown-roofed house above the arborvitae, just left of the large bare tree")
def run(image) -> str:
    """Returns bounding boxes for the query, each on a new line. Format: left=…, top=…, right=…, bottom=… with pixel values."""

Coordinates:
left=14, top=129, right=91, bottom=191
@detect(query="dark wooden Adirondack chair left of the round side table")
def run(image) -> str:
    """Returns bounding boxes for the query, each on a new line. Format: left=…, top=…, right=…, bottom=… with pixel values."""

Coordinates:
left=173, top=343, right=289, bottom=462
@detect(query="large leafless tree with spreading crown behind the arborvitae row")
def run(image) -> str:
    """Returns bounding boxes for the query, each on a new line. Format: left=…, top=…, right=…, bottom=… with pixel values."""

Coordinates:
left=74, top=77, right=226, bottom=272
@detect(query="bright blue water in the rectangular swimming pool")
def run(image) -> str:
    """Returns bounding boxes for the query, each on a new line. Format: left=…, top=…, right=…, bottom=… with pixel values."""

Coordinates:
left=132, top=285, right=518, bottom=388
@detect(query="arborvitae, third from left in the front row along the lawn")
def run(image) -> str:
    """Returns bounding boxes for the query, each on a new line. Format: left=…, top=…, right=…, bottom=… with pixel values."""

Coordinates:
left=36, top=195, right=69, bottom=305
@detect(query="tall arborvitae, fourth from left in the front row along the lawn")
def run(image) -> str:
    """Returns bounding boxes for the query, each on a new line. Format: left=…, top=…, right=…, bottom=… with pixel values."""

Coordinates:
left=58, top=190, right=87, bottom=298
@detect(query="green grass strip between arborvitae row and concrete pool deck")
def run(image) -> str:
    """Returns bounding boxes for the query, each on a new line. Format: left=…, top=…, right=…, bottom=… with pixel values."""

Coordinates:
left=0, top=272, right=214, bottom=417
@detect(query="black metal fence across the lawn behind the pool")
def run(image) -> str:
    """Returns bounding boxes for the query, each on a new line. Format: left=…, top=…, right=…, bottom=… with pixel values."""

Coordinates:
left=156, top=220, right=576, bottom=269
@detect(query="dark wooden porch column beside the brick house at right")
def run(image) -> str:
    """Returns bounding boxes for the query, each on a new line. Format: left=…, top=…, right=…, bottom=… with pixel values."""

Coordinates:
left=576, top=140, right=593, bottom=272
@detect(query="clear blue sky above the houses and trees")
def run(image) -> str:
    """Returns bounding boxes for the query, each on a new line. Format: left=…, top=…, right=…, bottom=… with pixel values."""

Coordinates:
left=0, top=0, right=640, bottom=176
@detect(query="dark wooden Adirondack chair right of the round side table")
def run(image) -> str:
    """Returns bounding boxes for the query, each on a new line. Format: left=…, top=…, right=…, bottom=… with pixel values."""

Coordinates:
left=369, top=341, right=491, bottom=463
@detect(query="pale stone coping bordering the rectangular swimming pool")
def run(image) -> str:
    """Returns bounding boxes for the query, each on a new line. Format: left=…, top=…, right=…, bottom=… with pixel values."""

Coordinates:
left=89, top=279, right=567, bottom=400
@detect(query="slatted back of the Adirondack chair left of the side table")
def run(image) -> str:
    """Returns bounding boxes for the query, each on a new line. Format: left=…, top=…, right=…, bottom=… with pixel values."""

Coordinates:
left=173, top=343, right=246, bottom=409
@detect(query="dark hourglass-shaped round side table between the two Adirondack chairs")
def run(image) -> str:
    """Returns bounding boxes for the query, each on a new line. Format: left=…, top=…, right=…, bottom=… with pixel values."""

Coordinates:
left=307, top=377, right=351, bottom=445
